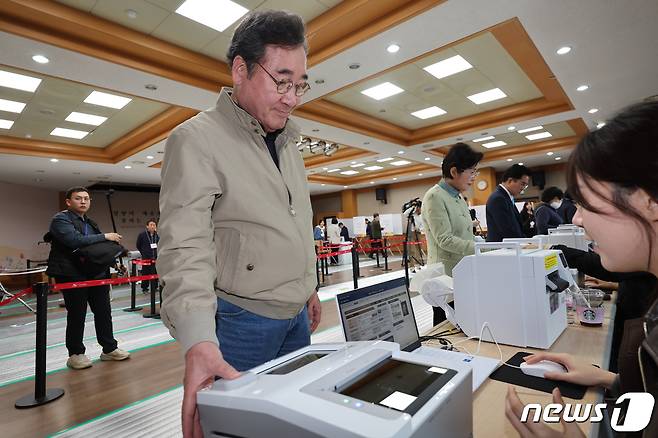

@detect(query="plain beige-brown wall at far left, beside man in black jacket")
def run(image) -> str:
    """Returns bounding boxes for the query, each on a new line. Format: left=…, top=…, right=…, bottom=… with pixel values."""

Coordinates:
left=0, top=182, right=59, bottom=269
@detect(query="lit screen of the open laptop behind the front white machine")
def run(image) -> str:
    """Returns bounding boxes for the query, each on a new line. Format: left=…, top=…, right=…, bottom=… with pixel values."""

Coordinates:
left=336, top=277, right=420, bottom=350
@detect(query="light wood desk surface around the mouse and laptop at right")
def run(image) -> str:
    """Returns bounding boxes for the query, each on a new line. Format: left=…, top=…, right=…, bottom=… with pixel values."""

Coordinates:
left=426, top=295, right=615, bottom=438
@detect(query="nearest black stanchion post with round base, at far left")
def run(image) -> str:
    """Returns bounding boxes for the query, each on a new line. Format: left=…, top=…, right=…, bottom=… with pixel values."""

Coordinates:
left=14, top=282, right=64, bottom=409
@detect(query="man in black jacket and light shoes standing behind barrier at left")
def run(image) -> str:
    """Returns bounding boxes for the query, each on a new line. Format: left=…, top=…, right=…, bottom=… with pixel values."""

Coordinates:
left=46, top=187, right=130, bottom=370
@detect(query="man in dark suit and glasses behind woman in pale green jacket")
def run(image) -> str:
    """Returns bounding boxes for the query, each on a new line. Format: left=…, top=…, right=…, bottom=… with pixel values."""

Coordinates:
left=487, top=164, right=530, bottom=242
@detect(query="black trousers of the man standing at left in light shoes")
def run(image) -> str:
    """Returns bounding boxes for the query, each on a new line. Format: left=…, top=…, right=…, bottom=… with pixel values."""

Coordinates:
left=55, top=272, right=117, bottom=356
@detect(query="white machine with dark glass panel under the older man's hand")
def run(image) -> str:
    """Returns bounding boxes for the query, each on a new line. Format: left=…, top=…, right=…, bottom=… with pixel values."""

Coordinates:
left=197, top=341, right=473, bottom=438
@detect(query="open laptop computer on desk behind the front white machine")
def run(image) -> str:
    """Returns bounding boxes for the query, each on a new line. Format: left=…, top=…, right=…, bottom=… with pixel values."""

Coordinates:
left=336, top=277, right=499, bottom=392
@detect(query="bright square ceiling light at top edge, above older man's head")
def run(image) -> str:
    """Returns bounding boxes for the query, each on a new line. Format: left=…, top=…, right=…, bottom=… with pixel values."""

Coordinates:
left=176, top=0, right=249, bottom=32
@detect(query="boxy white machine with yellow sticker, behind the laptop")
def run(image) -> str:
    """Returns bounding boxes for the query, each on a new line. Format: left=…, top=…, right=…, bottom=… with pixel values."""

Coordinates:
left=453, top=242, right=574, bottom=349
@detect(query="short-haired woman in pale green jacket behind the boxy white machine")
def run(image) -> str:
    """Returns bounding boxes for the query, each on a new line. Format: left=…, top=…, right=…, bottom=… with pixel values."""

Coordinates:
left=422, top=143, right=482, bottom=325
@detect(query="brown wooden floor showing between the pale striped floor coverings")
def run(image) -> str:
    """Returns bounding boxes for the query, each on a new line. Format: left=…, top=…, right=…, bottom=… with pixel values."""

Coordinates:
left=0, top=255, right=400, bottom=437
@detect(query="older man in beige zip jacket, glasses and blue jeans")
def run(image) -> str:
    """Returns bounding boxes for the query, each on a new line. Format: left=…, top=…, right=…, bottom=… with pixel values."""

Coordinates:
left=158, top=11, right=320, bottom=436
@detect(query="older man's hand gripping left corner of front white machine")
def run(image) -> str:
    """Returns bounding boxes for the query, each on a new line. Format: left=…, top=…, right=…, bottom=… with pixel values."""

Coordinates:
left=182, top=342, right=240, bottom=438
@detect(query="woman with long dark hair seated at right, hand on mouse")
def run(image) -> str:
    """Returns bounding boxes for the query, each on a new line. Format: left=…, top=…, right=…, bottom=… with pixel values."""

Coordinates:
left=506, top=102, right=658, bottom=438
